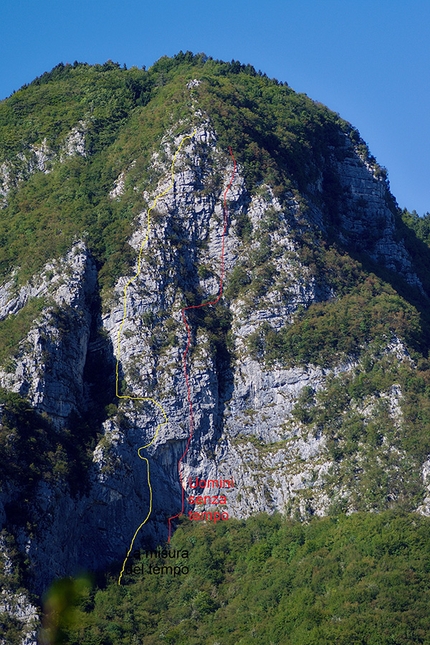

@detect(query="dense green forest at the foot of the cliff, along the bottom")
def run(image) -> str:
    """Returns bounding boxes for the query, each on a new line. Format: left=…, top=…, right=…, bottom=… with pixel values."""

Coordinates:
left=38, top=512, right=430, bottom=645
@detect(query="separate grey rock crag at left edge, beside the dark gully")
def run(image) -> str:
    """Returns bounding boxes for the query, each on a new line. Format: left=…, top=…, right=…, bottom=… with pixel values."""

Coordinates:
left=0, top=243, right=97, bottom=425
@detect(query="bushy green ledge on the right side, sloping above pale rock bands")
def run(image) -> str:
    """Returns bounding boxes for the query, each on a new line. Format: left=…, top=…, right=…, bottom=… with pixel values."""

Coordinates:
left=248, top=275, right=423, bottom=366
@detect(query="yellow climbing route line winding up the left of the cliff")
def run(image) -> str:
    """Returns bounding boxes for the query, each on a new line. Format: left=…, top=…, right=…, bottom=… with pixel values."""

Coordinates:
left=115, top=130, right=197, bottom=585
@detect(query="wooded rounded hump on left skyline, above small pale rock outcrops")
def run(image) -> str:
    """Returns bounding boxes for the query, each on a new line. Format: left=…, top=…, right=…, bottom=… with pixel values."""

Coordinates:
left=0, top=61, right=152, bottom=159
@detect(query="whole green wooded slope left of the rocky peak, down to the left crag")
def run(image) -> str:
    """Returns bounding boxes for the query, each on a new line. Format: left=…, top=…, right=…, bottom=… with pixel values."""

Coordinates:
left=0, top=56, right=198, bottom=287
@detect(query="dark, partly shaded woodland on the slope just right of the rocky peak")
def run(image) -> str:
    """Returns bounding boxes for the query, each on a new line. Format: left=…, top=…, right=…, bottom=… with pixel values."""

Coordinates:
left=197, top=69, right=355, bottom=195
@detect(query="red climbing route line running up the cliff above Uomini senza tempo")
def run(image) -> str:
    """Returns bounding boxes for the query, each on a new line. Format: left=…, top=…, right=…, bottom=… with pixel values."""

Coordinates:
left=167, top=146, right=236, bottom=543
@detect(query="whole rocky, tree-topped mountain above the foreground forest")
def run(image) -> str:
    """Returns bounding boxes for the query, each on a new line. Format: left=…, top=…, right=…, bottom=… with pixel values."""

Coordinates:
left=0, top=52, right=430, bottom=645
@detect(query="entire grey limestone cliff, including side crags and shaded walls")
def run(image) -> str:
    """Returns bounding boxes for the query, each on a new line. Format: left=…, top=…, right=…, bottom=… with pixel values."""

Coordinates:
left=0, top=55, right=429, bottom=642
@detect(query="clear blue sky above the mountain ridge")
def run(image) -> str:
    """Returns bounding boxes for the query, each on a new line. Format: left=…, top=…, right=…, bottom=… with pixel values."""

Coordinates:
left=0, top=0, right=430, bottom=214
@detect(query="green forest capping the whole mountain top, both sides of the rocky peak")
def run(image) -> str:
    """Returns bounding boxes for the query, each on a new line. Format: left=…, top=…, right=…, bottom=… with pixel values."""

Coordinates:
left=0, top=54, right=359, bottom=286
